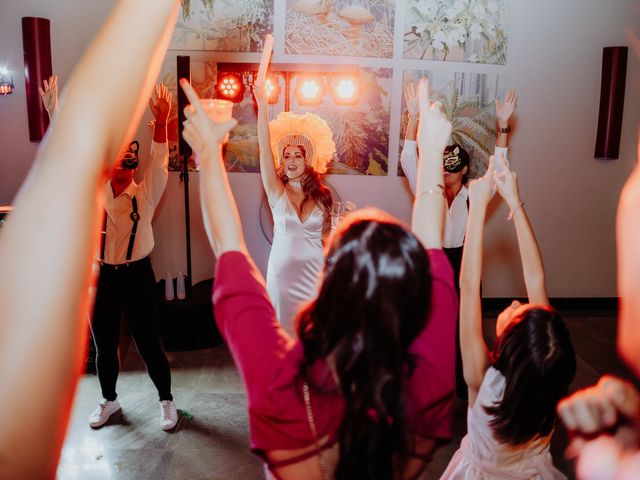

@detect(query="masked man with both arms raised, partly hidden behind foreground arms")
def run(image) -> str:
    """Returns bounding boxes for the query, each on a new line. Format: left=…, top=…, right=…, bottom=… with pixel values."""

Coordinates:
left=400, top=85, right=518, bottom=399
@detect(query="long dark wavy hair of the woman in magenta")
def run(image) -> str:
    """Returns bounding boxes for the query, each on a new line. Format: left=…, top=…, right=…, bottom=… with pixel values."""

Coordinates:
left=297, top=210, right=431, bottom=479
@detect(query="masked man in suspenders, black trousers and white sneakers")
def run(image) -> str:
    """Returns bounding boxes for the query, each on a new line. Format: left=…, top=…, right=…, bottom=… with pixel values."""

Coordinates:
left=89, top=84, right=178, bottom=430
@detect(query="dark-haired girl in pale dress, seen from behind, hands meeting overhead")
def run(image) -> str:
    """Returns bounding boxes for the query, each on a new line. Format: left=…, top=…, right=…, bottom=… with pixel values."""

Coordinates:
left=441, top=157, right=576, bottom=480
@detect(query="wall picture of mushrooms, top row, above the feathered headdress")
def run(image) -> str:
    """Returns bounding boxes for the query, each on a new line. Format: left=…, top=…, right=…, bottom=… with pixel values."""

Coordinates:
left=285, top=0, right=395, bottom=58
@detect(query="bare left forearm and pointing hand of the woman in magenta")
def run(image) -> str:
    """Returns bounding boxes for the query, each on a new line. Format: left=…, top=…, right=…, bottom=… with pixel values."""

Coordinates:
left=180, top=79, right=247, bottom=257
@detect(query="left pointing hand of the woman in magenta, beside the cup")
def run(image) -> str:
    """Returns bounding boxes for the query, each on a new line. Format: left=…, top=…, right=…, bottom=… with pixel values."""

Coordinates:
left=180, top=79, right=238, bottom=160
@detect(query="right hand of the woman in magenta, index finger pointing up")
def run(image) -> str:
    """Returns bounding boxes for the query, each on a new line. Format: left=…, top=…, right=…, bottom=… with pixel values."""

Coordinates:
left=418, top=78, right=451, bottom=154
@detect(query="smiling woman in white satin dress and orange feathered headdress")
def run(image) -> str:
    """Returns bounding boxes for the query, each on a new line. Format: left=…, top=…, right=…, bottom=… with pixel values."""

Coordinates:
left=253, top=80, right=335, bottom=335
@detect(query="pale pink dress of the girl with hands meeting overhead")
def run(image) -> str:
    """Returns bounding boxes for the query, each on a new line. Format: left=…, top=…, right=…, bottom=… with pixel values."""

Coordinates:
left=440, top=367, right=566, bottom=480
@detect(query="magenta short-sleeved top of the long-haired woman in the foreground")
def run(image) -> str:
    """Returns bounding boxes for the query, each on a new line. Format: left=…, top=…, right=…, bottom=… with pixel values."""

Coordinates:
left=213, top=250, right=458, bottom=468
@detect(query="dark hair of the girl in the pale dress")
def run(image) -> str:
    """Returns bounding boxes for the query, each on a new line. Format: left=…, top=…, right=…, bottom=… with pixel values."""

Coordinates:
left=485, top=306, right=576, bottom=445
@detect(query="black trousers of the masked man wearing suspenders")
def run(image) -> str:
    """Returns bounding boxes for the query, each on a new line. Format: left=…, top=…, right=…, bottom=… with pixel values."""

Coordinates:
left=91, top=257, right=173, bottom=400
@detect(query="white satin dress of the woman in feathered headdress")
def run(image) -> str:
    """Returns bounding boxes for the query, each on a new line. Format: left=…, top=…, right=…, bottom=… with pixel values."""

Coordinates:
left=267, top=192, right=324, bottom=335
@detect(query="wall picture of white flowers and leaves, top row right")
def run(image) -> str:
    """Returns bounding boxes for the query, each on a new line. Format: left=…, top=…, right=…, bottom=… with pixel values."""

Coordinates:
left=403, top=0, right=508, bottom=65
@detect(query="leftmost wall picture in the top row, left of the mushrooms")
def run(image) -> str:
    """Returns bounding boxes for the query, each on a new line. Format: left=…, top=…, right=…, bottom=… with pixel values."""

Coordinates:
left=174, top=0, right=274, bottom=52
